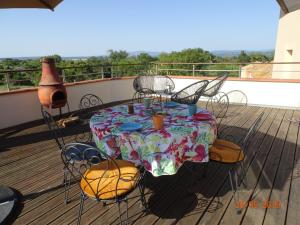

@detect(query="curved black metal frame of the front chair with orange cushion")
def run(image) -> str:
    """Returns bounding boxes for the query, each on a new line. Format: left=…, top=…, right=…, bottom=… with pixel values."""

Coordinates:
left=61, top=143, right=146, bottom=224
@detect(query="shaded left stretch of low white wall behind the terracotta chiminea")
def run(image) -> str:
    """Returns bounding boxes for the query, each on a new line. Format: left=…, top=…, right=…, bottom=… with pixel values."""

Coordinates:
left=0, top=79, right=134, bottom=129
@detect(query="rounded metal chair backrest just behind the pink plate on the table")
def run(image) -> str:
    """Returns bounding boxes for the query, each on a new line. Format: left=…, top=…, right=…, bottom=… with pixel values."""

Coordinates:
left=206, top=92, right=229, bottom=127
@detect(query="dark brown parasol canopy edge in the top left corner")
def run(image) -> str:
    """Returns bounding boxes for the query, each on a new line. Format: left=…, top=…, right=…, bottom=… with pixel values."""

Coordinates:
left=0, top=0, right=63, bottom=11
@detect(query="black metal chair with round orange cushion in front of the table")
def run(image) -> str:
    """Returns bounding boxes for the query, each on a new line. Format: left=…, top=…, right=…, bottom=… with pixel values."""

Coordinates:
left=61, top=143, right=146, bottom=224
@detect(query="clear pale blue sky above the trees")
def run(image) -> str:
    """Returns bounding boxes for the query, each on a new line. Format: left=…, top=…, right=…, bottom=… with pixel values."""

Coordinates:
left=0, top=0, right=279, bottom=58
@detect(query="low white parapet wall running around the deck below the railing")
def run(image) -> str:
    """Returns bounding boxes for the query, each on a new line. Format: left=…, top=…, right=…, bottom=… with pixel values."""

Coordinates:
left=0, top=77, right=300, bottom=129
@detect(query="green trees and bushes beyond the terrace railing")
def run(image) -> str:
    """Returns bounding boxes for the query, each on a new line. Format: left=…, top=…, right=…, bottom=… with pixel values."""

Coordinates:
left=0, top=48, right=273, bottom=89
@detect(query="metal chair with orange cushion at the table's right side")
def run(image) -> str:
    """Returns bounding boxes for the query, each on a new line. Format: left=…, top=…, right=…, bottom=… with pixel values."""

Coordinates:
left=209, top=113, right=264, bottom=213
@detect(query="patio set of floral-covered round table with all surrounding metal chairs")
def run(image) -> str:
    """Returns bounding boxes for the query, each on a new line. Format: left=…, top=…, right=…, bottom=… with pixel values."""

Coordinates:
left=42, top=75, right=263, bottom=224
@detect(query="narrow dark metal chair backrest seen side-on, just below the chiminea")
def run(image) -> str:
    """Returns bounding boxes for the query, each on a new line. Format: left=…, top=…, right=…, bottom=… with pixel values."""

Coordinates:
left=41, top=106, right=65, bottom=149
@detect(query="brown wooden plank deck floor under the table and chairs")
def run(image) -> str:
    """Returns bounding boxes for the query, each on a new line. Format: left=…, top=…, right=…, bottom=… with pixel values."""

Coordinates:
left=0, top=106, right=300, bottom=225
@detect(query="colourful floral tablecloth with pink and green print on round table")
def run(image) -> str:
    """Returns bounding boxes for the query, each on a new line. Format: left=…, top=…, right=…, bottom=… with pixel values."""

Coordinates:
left=90, top=104, right=217, bottom=176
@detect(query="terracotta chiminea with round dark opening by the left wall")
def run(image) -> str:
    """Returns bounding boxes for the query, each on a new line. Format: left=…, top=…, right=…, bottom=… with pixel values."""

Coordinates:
left=38, top=58, right=67, bottom=108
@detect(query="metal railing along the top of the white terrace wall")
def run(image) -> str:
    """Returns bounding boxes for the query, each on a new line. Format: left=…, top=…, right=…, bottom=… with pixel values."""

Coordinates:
left=0, top=62, right=300, bottom=91
